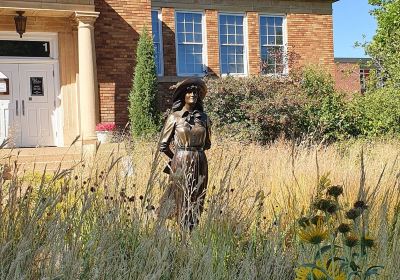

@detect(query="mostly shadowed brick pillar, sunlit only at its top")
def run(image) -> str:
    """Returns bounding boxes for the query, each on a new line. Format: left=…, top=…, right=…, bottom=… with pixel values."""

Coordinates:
left=161, top=8, right=176, bottom=76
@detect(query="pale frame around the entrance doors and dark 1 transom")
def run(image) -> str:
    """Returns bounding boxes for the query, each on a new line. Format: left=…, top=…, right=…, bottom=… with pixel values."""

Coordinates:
left=0, top=31, right=64, bottom=147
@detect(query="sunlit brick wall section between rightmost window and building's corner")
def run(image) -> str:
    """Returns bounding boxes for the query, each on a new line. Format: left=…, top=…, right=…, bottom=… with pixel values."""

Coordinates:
left=287, top=14, right=334, bottom=76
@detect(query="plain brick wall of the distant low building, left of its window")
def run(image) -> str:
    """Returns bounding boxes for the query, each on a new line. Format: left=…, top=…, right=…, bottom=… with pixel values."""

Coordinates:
left=335, top=63, right=361, bottom=93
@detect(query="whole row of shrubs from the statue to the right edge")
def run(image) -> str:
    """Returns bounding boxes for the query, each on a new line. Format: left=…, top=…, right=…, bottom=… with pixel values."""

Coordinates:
left=205, top=67, right=400, bottom=144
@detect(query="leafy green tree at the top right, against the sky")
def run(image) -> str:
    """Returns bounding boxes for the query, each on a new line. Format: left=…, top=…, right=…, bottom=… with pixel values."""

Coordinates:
left=366, top=0, right=400, bottom=88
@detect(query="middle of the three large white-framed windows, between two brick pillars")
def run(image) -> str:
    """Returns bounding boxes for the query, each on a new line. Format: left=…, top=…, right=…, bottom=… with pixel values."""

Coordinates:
left=219, top=14, right=246, bottom=74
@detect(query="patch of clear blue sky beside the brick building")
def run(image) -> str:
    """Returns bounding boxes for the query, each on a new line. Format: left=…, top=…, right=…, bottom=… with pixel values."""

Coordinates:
left=333, top=0, right=376, bottom=57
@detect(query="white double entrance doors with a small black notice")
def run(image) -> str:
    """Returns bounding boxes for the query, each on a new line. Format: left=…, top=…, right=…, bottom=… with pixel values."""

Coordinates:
left=0, top=64, right=55, bottom=147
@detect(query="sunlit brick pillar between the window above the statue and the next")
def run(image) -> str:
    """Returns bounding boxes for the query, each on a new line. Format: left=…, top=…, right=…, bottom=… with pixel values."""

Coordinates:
left=206, top=10, right=221, bottom=76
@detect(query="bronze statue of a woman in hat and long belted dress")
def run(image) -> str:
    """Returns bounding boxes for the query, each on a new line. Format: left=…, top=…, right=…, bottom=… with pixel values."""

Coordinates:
left=159, top=78, right=211, bottom=230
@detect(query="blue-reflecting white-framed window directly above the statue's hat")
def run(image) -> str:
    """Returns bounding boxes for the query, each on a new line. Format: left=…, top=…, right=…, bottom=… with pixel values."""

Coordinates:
left=176, top=12, right=205, bottom=76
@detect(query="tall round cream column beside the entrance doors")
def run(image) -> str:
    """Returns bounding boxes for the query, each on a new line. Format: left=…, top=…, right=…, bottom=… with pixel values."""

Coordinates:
left=75, top=12, right=99, bottom=141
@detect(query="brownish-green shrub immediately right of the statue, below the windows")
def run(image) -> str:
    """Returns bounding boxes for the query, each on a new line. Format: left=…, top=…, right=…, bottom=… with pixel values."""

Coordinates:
left=205, top=76, right=303, bottom=143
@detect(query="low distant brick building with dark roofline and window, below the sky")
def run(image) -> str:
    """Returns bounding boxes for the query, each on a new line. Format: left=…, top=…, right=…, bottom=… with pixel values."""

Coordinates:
left=335, top=58, right=371, bottom=93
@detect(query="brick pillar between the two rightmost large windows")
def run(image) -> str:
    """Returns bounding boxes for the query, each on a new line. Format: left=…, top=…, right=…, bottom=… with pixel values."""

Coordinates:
left=247, top=12, right=261, bottom=75
